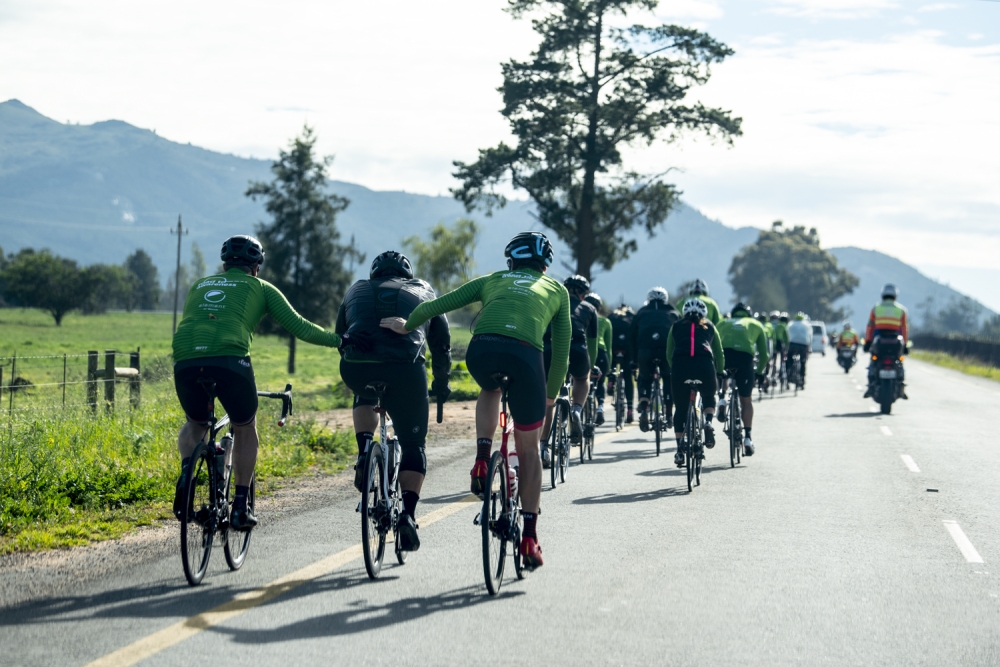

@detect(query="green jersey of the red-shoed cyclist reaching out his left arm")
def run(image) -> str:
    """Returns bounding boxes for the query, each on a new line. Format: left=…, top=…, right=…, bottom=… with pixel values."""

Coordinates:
left=406, top=269, right=572, bottom=398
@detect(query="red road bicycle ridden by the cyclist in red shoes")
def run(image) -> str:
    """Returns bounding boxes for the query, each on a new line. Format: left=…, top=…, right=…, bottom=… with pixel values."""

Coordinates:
left=473, top=374, right=528, bottom=595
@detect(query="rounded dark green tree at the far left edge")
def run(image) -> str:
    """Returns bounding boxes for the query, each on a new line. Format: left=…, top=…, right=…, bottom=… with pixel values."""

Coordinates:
left=3, top=248, right=86, bottom=326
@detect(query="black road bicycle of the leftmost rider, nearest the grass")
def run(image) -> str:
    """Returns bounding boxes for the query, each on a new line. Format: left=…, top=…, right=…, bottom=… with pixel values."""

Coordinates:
left=181, top=377, right=292, bottom=586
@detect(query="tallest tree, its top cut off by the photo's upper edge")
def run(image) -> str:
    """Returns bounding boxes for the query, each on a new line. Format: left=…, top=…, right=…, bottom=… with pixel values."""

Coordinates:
left=452, top=0, right=741, bottom=278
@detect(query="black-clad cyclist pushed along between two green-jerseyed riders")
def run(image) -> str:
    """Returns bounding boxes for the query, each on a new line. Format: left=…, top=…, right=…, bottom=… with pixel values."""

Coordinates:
left=334, top=250, right=451, bottom=551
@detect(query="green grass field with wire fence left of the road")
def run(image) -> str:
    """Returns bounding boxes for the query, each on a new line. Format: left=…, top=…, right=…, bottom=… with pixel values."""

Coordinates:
left=0, top=309, right=477, bottom=553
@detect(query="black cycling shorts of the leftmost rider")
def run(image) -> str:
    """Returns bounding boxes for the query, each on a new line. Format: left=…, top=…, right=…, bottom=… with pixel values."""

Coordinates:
left=174, top=357, right=257, bottom=426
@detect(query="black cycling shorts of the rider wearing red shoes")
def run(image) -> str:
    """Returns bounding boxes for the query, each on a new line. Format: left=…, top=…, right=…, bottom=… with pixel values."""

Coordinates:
left=465, top=334, right=546, bottom=431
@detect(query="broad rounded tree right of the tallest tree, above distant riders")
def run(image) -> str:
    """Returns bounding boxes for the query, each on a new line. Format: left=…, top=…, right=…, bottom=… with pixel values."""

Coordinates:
left=729, top=220, right=859, bottom=321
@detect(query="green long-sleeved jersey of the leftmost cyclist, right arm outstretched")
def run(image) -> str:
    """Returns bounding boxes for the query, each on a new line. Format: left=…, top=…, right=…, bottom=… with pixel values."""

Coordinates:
left=173, top=268, right=340, bottom=362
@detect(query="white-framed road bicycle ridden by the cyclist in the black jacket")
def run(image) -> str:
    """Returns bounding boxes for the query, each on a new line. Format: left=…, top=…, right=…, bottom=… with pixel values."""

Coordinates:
left=357, top=382, right=412, bottom=579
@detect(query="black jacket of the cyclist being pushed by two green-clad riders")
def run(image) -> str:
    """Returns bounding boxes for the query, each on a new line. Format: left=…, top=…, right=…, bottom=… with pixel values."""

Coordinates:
left=335, top=277, right=451, bottom=379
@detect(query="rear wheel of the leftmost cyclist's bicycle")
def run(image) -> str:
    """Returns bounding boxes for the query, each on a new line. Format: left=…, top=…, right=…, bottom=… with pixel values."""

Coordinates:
left=181, top=443, right=216, bottom=586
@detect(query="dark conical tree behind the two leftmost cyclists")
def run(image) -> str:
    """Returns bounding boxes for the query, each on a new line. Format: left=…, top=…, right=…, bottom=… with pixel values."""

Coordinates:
left=246, top=125, right=364, bottom=373
